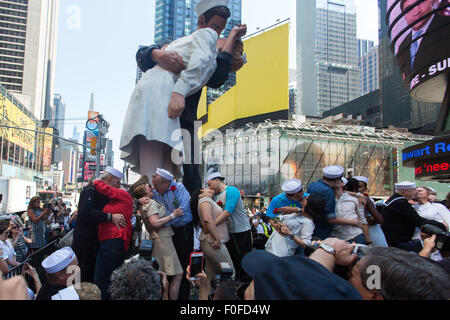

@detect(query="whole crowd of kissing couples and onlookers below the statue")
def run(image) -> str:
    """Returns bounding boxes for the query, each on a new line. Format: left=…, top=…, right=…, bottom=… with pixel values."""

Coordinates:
left=0, top=162, right=450, bottom=301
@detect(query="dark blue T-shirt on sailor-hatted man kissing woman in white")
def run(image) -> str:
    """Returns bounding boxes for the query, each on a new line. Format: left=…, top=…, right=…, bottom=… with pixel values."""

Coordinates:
left=308, top=179, right=336, bottom=240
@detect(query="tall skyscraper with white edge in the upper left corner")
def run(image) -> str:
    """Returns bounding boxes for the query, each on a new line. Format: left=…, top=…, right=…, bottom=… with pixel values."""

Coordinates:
left=0, top=0, right=59, bottom=120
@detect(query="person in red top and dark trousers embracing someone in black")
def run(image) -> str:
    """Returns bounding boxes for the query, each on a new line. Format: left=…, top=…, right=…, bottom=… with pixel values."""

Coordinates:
left=94, top=169, right=133, bottom=300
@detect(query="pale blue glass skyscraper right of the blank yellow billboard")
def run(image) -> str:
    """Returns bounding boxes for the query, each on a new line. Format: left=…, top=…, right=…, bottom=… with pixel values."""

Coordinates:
left=297, top=0, right=361, bottom=116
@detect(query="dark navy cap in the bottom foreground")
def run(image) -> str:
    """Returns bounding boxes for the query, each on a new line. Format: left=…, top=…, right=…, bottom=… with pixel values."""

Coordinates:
left=242, top=250, right=361, bottom=300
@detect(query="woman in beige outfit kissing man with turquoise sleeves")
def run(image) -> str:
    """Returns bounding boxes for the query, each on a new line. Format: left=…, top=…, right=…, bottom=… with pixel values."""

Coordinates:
left=191, top=189, right=236, bottom=279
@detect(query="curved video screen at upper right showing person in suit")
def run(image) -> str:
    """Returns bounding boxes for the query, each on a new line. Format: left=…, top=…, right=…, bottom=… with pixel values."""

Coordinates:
left=386, top=0, right=450, bottom=103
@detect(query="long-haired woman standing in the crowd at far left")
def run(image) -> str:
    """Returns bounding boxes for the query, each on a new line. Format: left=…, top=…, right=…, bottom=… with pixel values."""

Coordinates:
left=27, top=197, right=47, bottom=252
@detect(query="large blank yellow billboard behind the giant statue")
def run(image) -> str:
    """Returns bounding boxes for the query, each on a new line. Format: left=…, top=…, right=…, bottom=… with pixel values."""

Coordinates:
left=197, top=23, right=289, bottom=137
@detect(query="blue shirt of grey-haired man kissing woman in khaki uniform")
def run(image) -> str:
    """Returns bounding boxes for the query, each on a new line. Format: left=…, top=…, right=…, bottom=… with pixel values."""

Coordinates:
left=153, top=181, right=192, bottom=228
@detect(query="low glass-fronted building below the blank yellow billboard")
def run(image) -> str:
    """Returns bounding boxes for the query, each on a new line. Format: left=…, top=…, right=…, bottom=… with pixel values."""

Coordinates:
left=203, top=120, right=431, bottom=198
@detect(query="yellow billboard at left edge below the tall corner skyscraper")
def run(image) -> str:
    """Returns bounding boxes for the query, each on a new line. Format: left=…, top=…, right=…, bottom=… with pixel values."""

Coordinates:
left=0, top=90, right=36, bottom=152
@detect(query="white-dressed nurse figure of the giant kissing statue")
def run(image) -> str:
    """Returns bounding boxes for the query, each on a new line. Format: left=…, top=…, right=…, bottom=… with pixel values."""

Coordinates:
left=120, top=0, right=247, bottom=178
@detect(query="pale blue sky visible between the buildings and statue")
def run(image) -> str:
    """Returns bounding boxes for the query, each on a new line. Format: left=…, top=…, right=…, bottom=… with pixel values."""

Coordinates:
left=55, top=0, right=378, bottom=169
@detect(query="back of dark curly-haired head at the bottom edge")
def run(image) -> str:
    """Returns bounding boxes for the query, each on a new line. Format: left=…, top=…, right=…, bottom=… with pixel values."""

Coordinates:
left=109, top=258, right=169, bottom=300
